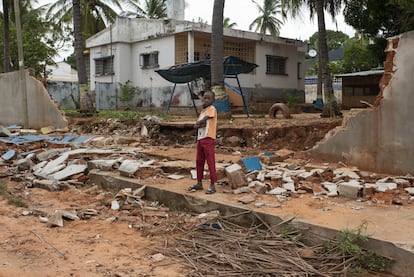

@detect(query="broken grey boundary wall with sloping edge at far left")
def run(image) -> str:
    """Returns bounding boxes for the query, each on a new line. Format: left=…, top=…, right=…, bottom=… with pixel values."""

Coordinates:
left=0, top=71, right=67, bottom=129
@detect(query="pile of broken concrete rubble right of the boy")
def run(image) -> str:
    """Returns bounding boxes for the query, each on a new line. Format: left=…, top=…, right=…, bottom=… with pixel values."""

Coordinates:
left=225, top=149, right=414, bottom=206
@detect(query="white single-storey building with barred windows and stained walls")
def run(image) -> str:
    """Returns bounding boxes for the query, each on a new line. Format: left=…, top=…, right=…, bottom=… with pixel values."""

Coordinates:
left=86, top=18, right=306, bottom=109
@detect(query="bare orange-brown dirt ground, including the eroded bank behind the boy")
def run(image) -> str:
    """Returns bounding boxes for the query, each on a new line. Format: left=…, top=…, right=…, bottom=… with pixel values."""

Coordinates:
left=0, top=111, right=404, bottom=277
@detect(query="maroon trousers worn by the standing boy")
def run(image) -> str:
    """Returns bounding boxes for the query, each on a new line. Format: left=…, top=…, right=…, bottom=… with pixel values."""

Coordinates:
left=196, top=138, right=217, bottom=184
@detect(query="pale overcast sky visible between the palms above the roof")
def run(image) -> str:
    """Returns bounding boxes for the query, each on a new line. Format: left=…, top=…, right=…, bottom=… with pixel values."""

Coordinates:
left=31, top=0, right=355, bottom=59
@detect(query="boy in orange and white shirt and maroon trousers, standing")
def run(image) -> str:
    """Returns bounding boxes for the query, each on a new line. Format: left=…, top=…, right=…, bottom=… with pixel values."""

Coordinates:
left=188, top=91, right=217, bottom=194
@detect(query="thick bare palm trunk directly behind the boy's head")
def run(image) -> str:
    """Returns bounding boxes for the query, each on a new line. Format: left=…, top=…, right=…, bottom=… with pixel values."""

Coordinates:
left=211, top=0, right=225, bottom=100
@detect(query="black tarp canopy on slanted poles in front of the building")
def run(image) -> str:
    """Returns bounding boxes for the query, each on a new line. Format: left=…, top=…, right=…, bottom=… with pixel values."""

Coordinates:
left=155, top=56, right=257, bottom=115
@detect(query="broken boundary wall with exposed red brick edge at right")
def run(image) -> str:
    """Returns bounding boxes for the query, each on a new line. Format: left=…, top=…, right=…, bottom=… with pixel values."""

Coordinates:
left=309, top=31, right=414, bottom=174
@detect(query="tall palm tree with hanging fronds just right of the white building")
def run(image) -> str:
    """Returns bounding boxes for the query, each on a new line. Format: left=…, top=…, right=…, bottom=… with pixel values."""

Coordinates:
left=282, top=0, right=346, bottom=116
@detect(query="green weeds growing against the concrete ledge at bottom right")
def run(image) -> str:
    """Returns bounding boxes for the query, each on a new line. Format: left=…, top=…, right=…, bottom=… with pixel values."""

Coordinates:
left=326, top=222, right=390, bottom=275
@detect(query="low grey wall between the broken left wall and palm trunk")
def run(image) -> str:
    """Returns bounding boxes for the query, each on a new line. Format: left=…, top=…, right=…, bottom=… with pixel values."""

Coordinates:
left=46, top=81, right=79, bottom=109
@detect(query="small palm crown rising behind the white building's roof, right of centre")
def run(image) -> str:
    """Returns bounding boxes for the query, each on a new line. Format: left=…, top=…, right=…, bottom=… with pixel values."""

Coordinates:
left=249, top=0, right=283, bottom=36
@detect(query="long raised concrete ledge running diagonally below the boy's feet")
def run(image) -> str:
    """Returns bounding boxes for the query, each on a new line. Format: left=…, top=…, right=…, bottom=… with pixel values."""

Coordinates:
left=89, top=170, right=414, bottom=277
